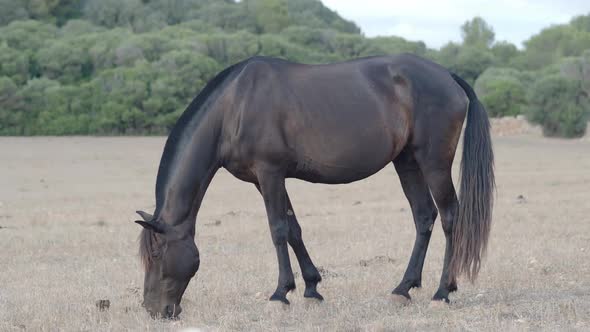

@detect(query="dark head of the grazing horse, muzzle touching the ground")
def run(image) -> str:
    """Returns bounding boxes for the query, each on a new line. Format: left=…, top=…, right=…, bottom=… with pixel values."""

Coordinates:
left=136, top=211, right=200, bottom=318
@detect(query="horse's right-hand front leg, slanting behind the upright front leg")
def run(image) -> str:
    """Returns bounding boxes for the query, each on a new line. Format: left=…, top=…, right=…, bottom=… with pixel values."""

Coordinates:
left=256, top=185, right=324, bottom=301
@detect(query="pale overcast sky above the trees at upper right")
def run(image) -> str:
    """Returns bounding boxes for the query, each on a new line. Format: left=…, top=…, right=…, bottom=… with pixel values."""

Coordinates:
left=322, top=0, right=590, bottom=48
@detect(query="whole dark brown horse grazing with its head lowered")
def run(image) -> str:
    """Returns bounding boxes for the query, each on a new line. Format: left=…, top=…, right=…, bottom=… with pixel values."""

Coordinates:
left=136, top=54, right=494, bottom=317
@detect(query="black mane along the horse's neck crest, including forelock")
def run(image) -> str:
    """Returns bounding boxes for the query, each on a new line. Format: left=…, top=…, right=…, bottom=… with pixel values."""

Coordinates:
left=139, top=60, right=248, bottom=271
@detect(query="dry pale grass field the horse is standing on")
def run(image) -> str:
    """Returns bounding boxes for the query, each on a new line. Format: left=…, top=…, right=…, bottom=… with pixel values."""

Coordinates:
left=0, top=136, right=590, bottom=331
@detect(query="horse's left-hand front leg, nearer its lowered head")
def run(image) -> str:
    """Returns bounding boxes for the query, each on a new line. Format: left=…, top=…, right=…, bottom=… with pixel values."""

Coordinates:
left=258, top=171, right=295, bottom=304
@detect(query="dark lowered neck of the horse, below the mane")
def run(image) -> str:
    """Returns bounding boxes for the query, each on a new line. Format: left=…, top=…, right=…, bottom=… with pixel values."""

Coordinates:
left=156, top=109, right=220, bottom=226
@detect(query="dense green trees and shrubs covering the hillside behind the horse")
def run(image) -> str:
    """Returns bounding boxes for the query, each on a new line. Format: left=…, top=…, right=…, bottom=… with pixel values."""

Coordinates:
left=0, top=0, right=590, bottom=136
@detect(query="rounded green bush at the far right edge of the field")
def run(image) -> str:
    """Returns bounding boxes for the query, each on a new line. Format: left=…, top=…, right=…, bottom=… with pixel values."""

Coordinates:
left=527, top=75, right=590, bottom=138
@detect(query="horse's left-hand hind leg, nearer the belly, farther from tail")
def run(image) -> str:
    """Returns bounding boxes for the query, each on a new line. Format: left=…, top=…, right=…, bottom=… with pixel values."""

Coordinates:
left=392, top=151, right=437, bottom=300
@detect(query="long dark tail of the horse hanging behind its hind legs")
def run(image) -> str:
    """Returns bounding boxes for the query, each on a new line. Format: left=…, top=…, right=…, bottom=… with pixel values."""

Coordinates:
left=449, top=74, right=495, bottom=282
